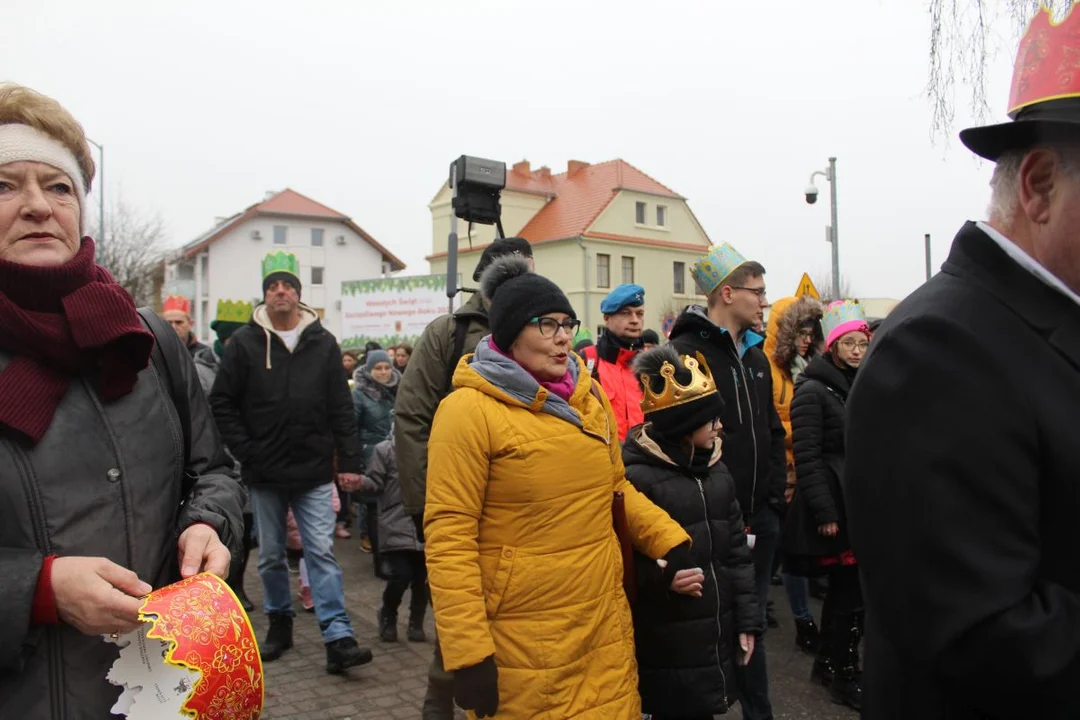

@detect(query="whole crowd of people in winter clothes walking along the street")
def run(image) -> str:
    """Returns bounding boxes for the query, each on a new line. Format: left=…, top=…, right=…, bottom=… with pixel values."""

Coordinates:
left=6, top=9, right=1080, bottom=720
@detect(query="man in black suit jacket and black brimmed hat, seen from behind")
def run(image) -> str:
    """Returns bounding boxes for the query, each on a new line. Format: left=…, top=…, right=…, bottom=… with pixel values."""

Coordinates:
left=845, top=13, right=1080, bottom=720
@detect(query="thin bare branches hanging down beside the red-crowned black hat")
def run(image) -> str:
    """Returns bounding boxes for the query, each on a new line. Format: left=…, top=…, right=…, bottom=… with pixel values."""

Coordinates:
left=926, top=0, right=1072, bottom=140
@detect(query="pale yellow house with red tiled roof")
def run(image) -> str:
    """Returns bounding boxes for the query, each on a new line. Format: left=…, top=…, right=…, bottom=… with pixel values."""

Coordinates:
left=428, top=160, right=712, bottom=335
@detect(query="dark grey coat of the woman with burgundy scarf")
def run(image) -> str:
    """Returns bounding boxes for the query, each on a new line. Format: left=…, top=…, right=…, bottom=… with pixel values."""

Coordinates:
left=0, top=321, right=243, bottom=720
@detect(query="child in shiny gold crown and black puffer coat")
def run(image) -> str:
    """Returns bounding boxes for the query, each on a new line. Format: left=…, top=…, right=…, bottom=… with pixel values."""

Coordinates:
left=623, top=345, right=762, bottom=720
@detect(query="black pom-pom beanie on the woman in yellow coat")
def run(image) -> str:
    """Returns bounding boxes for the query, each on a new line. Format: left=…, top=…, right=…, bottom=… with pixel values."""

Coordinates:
left=480, top=255, right=578, bottom=352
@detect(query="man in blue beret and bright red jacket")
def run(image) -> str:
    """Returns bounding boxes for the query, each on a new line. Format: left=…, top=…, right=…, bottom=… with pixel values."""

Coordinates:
left=582, top=285, right=645, bottom=443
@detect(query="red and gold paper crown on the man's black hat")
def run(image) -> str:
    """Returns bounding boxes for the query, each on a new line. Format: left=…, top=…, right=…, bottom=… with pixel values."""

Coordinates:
left=1009, top=2, right=1080, bottom=119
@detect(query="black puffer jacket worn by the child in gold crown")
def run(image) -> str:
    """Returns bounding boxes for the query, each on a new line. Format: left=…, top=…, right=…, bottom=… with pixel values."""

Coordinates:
left=622, top=426, right=761, bottom=717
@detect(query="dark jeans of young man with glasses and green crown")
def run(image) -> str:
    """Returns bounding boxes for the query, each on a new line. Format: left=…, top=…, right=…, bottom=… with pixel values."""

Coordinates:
left=735, top=505, right=780, bottom=720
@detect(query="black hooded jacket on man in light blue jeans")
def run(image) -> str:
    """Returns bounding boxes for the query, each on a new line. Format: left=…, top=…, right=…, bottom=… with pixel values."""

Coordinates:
left=210, top=305, right=364, bottom=490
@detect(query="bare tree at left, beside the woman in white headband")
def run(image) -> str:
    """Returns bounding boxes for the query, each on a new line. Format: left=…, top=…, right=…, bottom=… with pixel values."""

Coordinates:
left=87, top=196, right=165, bottom=305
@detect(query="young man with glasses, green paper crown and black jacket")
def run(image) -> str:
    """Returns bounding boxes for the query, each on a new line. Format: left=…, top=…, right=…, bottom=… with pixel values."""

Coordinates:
left=671, top=243, right=787, bottom=720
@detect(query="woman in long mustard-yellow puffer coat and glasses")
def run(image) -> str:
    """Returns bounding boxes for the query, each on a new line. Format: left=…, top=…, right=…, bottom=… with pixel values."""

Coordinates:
left=424, top=256, right=704, bottom=720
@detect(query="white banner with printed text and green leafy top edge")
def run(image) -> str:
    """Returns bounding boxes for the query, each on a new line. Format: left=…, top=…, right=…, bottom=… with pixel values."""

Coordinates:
left=341, top=275, right=460, bottom=348
